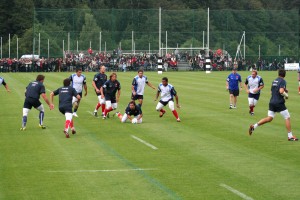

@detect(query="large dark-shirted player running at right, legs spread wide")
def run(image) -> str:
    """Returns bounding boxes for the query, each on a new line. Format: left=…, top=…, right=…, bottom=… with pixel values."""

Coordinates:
left=249, top=69, right=298, bottom=141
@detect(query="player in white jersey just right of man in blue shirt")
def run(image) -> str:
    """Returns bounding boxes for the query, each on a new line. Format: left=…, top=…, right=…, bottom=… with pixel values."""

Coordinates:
left=245, top=70, right=264, bottom=115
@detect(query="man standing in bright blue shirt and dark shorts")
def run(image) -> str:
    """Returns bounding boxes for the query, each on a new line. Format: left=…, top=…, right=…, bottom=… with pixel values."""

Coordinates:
left=226, top=67, right=243, bottom=109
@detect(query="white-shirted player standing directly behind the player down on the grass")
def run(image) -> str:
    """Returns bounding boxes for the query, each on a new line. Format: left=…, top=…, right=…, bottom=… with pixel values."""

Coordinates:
left=131, top=69, right=155, bottom=107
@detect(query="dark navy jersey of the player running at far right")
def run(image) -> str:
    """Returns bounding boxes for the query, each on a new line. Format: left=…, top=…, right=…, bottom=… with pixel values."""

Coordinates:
left=270, top=77, right=286, bottom=104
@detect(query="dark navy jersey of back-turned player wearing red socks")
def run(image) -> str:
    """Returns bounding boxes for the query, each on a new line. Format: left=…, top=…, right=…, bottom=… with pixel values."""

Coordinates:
left=53, top=86, right=77, bottom=108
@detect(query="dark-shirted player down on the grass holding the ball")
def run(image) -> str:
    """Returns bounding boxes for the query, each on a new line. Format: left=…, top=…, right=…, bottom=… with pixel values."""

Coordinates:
left=116, top=101, right=143, bottom=124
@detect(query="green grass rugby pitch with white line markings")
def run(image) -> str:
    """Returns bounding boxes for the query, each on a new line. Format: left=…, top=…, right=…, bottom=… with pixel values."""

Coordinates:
left=0, top=72, right=300, bottom=200
